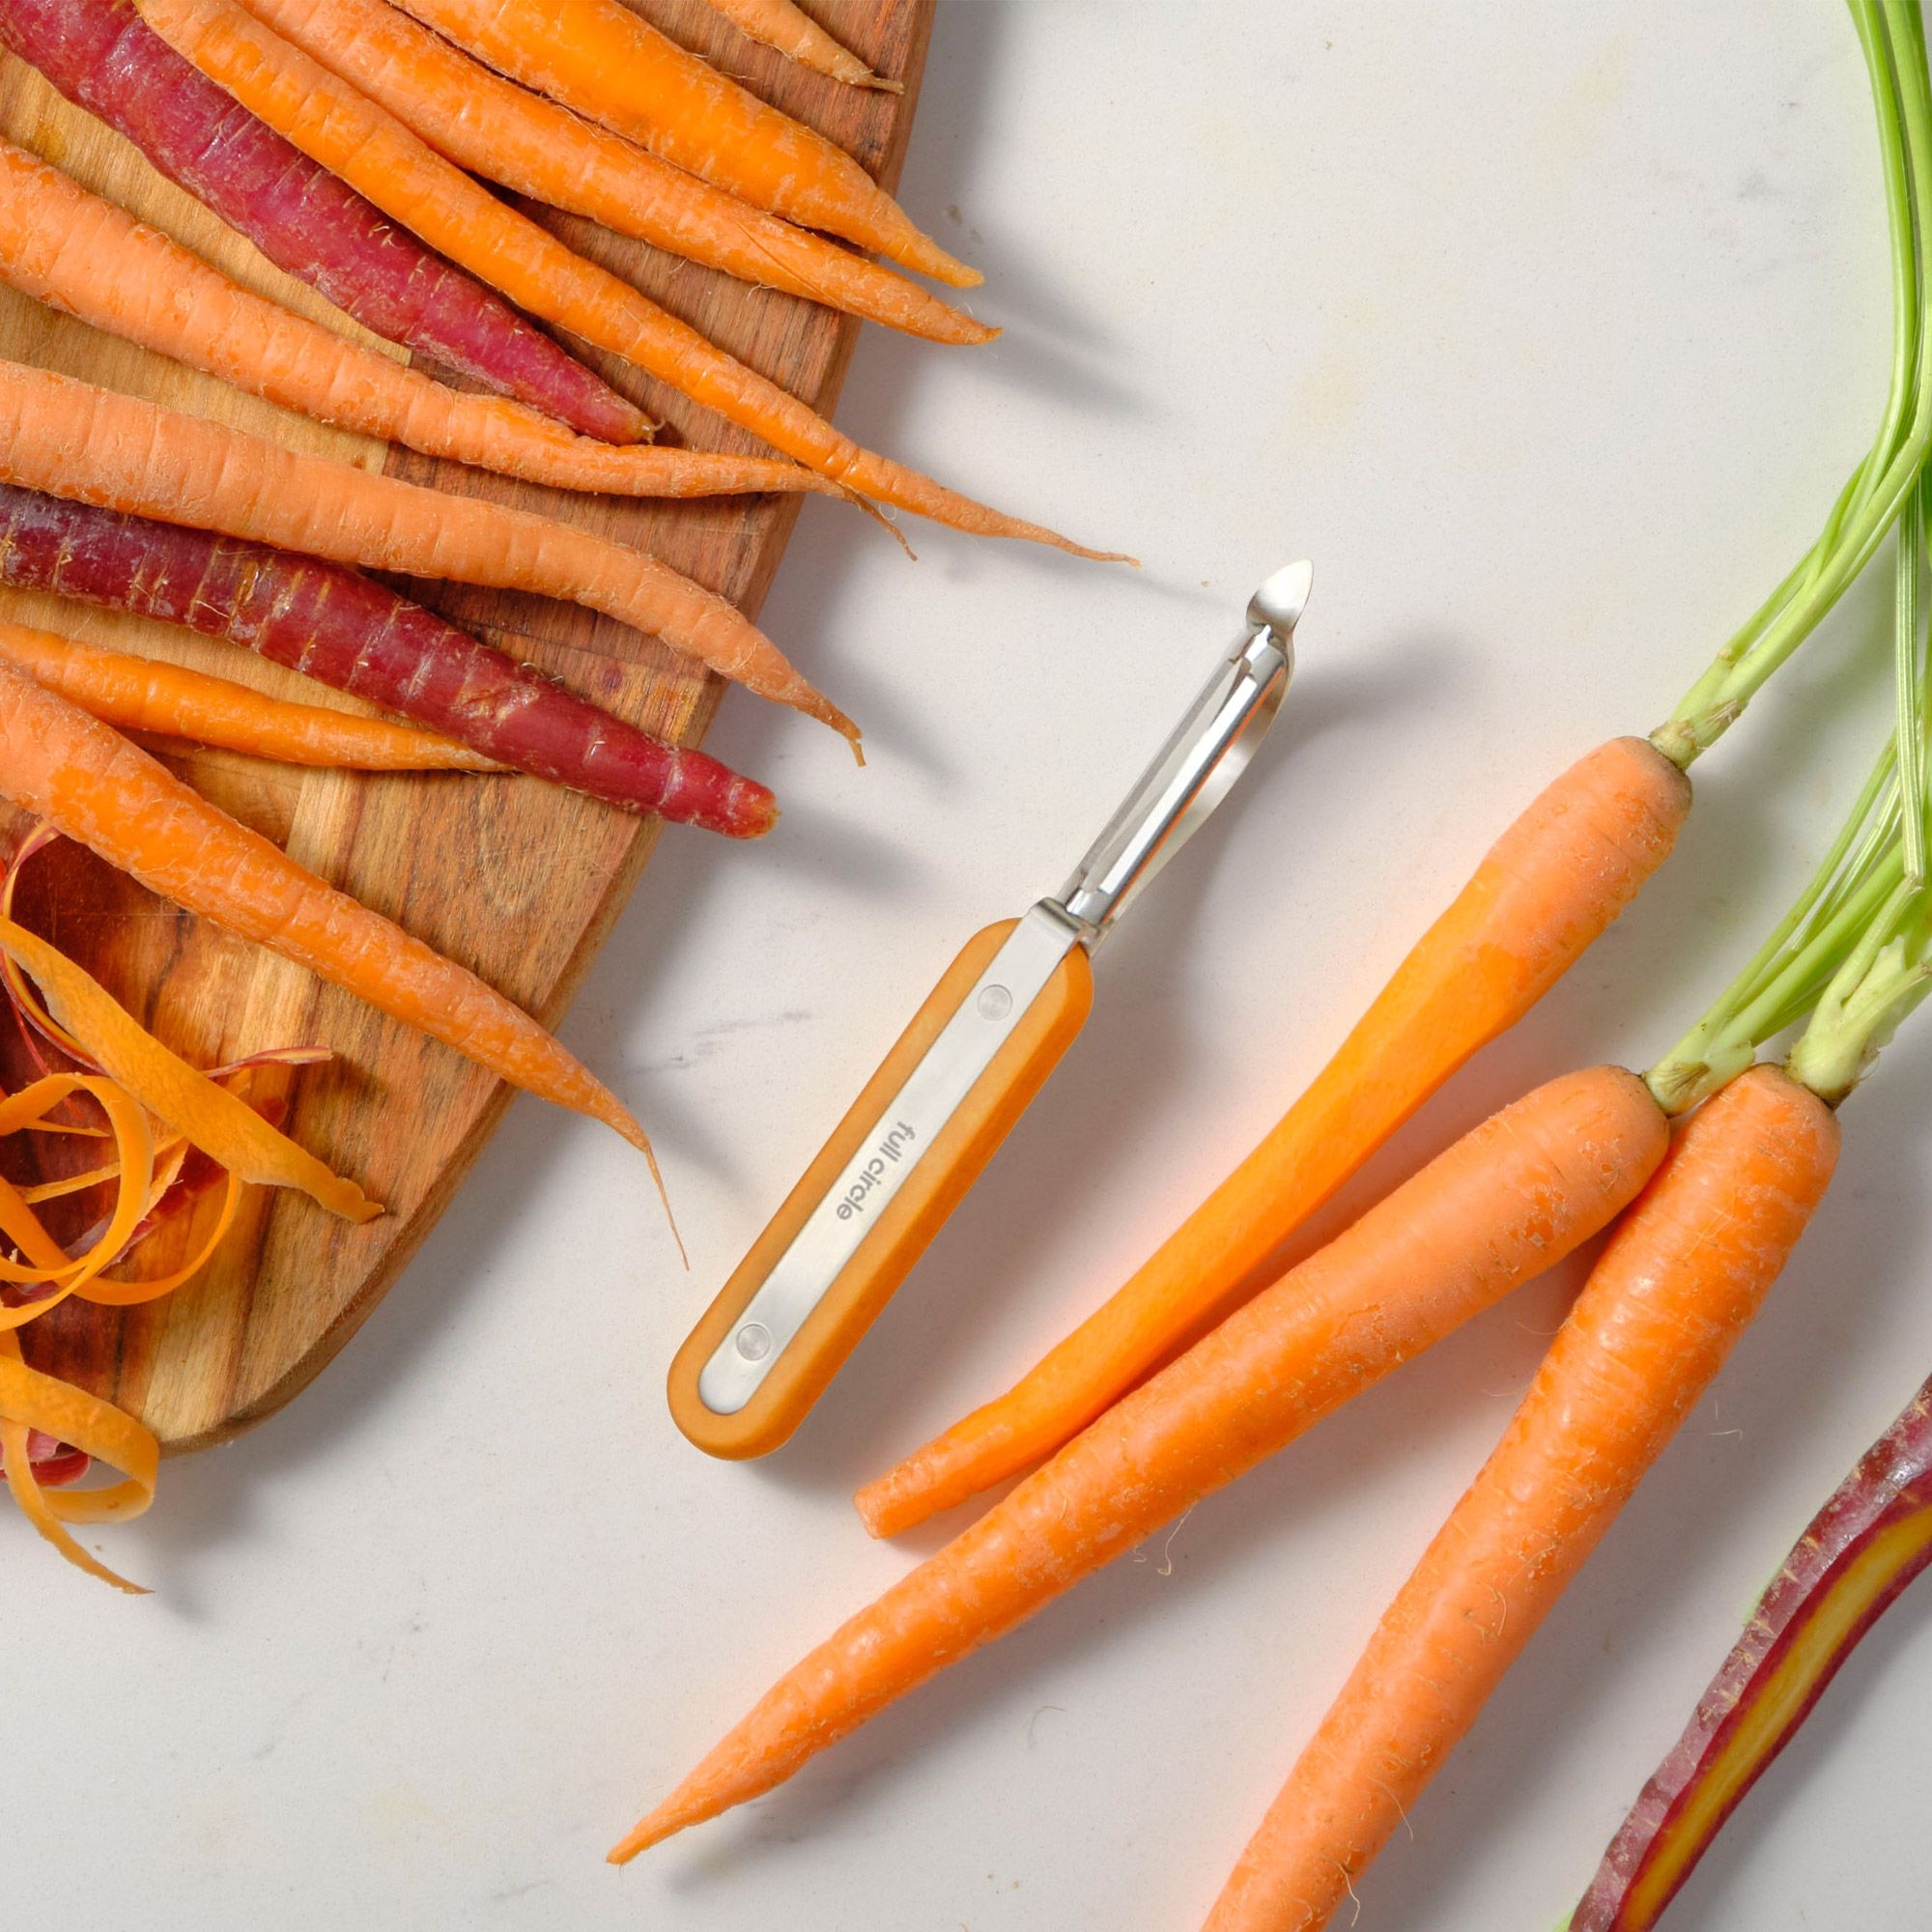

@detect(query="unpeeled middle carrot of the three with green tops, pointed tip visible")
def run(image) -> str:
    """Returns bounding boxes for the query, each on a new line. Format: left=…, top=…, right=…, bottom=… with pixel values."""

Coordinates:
left=611, top=1066, right=1667, bottom=1862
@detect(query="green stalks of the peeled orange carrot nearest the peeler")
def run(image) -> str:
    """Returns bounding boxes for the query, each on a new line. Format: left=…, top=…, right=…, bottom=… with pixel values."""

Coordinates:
left=1652, top=0, right=1932, bottom=769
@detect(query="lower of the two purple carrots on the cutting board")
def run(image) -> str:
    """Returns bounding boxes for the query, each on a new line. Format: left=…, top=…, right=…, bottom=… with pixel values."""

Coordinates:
left=0, top=483, right=777, bottom=838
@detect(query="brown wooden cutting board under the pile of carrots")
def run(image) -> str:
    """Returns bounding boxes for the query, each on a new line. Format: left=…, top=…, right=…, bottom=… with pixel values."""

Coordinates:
left=0, top=0, right=945, bottom=1451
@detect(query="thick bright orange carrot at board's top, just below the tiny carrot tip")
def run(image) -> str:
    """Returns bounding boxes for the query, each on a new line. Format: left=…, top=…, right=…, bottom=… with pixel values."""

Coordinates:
left=392, top=0, right=983, bottom=288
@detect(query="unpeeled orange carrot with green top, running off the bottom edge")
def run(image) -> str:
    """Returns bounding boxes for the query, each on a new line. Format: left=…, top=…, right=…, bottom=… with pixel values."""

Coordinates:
left=1208, top=1066, right=1839, bottom=1932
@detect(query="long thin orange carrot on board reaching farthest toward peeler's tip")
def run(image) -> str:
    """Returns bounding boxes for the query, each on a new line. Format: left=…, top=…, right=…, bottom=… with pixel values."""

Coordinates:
left=139, top=0, right=1099, bottom=556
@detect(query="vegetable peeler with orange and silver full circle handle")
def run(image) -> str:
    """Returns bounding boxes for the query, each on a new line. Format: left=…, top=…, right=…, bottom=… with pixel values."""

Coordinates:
left=668, top=562, right=1314, bottom=1457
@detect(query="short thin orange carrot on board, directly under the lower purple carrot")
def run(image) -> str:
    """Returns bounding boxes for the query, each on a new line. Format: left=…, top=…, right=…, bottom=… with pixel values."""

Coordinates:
left=0, top=624, right=502, bottom=771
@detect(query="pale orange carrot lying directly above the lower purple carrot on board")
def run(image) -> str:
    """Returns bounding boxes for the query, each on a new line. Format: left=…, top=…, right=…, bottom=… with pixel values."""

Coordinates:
left=0, top=361, right=858, bottom=742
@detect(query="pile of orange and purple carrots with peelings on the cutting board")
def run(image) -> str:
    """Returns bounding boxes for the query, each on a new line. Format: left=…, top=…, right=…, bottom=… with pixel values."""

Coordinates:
left=0, top=0, right=1105, bottom=1580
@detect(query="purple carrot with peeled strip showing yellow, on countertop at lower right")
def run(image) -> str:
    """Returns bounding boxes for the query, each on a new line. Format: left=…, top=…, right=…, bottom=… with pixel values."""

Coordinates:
left=1569, top=1381, right=1932, bottom=1932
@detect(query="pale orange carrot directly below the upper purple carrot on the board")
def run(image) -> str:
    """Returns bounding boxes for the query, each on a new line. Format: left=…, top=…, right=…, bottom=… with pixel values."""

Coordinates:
left=0, top=140, right=862, bottom=497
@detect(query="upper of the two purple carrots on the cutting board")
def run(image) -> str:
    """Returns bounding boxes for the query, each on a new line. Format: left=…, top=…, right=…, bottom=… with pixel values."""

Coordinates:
left=0, top=0, right=649, bottom=442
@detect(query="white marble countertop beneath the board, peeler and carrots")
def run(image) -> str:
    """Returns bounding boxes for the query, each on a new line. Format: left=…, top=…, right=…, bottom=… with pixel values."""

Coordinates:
left=14, top=0, right=1932, bottom=1932
